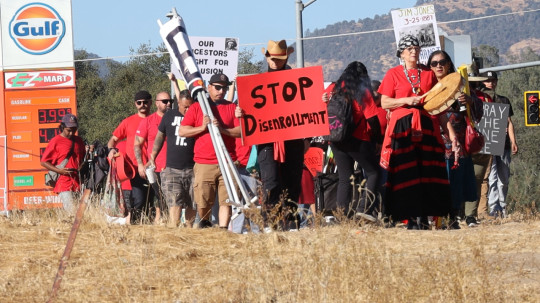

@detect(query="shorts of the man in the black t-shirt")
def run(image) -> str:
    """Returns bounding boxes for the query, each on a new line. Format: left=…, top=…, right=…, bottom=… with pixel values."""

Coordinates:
left=160, top=167, right=195, bottom=209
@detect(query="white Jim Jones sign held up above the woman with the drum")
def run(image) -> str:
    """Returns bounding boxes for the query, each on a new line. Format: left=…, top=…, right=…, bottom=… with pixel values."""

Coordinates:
left=391, top=5, right=441, bottom=64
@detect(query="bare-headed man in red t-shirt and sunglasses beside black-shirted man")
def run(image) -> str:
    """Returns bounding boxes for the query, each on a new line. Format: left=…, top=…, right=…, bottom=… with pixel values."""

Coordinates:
left=133, top=92, right=173, bottom=223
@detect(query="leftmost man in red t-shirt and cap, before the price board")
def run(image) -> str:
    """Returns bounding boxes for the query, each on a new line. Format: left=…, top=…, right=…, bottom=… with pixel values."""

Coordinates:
left=41, top=114, right=85, bottom=214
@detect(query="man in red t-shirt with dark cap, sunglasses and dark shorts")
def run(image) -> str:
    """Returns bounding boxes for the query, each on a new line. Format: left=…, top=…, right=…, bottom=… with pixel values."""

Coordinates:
left=107, top=90, right=153, bottom=222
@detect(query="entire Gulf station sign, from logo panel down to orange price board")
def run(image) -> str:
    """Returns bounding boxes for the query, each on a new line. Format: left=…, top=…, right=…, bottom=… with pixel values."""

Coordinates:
left=0, top=0, right=77, bottom=211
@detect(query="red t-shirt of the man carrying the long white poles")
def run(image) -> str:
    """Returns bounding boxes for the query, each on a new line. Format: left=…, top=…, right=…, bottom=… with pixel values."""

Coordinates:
left=180, top=100, right=240, bottom=164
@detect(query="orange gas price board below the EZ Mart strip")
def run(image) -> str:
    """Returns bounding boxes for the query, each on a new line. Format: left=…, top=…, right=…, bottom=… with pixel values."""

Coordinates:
left=5, top=87, right=76, bottom=209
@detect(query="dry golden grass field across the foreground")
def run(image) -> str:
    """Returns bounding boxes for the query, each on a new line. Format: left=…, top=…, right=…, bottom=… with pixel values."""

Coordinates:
left=0, top=207, right=540, bottom=303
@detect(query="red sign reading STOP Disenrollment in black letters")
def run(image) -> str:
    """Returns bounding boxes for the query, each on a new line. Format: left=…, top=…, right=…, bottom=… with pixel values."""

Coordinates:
left=237, top=66, right=329, bottom=145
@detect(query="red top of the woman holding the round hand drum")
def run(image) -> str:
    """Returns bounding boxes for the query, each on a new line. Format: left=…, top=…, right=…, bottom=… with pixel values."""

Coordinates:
left=378, top=65, right=437, bottom=99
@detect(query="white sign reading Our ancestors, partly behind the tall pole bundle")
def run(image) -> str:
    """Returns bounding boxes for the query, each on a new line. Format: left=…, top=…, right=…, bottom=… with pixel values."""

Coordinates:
left=171, top=36, right=239, bottom=82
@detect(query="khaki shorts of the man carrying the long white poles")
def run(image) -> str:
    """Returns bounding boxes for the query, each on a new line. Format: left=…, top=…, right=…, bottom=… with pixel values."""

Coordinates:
left=193, top=163, right=237, bottom=208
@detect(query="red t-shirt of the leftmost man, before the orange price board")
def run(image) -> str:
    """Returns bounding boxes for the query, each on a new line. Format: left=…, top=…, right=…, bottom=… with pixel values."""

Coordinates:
left=41, top=135, right=85, bottom=193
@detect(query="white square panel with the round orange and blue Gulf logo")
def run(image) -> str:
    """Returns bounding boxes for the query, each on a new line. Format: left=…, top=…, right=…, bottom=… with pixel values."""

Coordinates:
left=0, top=0, right=73, bottom=70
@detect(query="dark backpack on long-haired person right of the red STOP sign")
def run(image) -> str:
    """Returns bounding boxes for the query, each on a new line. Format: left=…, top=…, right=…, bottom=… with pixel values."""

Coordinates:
left=324, top=94, right=356, bottom=142
